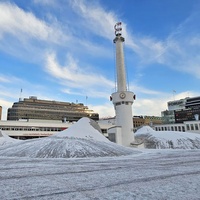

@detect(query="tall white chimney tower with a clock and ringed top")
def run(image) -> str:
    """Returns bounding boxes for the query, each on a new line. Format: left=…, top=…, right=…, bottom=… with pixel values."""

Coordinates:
left=110, top=22, right=134, bottom=146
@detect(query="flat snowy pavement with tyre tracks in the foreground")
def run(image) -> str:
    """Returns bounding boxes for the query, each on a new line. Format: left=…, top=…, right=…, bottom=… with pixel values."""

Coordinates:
left=0, top=150, right=200, bottom=200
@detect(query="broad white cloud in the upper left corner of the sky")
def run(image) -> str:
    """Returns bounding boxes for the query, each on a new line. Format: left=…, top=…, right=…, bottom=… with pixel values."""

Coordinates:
left=0, top=3, right=66, bottom=43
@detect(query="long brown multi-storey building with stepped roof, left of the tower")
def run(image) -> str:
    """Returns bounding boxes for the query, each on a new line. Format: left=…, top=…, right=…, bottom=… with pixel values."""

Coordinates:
left=7, top=96, right=99, bottom=122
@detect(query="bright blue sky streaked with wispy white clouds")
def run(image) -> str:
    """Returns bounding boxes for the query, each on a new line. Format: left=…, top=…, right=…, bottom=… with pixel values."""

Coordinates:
left=0, top=0, right=200, bottom=119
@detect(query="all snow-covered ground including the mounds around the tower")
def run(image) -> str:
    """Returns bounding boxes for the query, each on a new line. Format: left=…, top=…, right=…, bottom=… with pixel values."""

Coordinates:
left=0, top=119, right=200, bottom=200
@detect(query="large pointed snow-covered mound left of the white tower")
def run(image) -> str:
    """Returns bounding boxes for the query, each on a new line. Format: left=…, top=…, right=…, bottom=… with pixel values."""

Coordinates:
left=0, top=118, right=139, bottom=158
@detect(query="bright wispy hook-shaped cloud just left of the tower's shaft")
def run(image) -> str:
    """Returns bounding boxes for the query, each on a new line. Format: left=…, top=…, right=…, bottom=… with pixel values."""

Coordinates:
left=46, top=53, right=114, bottom=95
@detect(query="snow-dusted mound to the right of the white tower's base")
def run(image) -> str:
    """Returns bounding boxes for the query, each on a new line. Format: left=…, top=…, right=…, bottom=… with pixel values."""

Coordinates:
left=135, top=126, right=200, bottom=149
